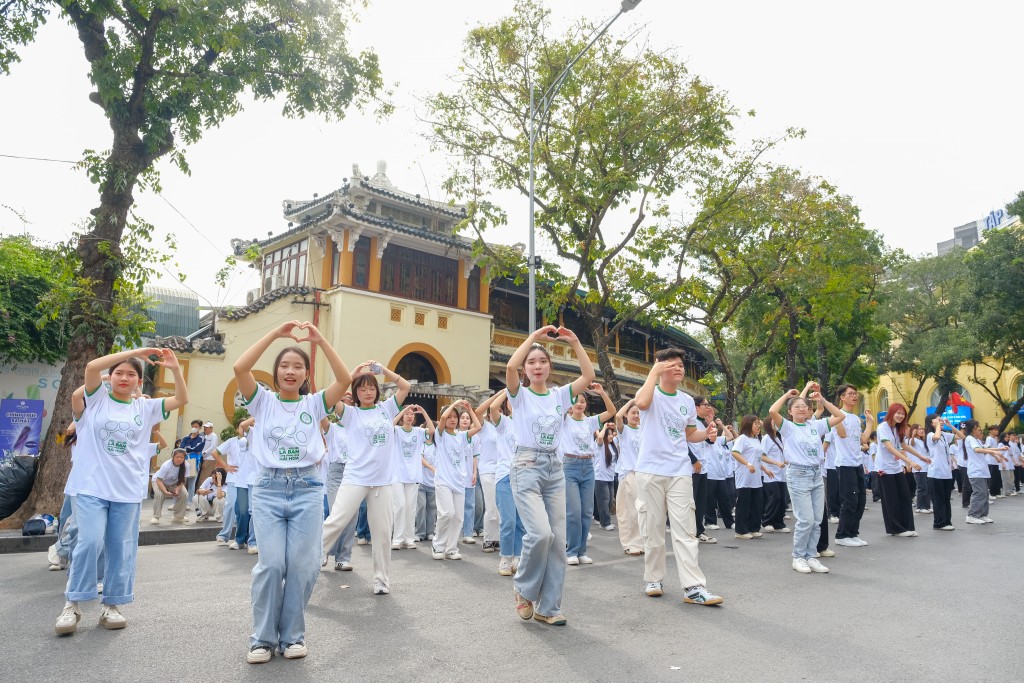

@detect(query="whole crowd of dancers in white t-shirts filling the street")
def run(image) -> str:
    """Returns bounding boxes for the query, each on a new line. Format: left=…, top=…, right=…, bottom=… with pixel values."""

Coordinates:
left=44, top=322, right=1024, bottom=664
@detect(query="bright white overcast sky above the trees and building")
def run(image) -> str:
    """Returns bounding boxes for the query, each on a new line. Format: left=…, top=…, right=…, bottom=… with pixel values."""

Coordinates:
left=0, top=0, right=1024, bottom=305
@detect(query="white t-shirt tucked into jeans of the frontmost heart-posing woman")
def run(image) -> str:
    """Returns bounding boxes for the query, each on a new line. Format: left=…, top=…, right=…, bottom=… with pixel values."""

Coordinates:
left=246, top=385, right=332, bottom=469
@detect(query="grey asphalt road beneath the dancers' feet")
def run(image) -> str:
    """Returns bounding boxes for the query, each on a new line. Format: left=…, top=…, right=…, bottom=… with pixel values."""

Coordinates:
left=0, top=496, right=1024, bottom=683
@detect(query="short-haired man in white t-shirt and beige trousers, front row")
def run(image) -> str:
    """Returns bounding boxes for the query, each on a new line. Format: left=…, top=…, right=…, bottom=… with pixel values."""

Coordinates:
left=635, top=348, right=722, bottom=605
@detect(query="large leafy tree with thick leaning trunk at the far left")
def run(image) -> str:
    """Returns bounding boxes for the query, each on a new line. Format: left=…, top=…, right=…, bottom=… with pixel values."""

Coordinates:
left=0, top=0, right=386, bottom=518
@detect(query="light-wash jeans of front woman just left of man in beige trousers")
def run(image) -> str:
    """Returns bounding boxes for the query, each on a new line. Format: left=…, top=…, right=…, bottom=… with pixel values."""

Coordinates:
left=509, top=447, right=566, bottom=616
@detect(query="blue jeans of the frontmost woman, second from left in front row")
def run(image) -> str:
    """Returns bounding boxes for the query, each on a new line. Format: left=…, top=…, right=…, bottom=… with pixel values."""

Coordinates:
left=249, top=467, right=324, bottom=650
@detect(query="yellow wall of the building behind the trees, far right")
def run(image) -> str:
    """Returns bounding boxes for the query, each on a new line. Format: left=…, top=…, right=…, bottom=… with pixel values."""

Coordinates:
left=865, top=360, right=1024, bottom=426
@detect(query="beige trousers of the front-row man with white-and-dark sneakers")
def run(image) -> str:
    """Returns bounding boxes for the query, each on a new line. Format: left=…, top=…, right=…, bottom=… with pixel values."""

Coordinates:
left=636, top=472, right=706, bottom=589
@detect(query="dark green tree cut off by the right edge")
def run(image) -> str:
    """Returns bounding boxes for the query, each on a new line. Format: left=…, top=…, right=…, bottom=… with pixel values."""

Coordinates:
left=965, top=222, right=1024, bottom=431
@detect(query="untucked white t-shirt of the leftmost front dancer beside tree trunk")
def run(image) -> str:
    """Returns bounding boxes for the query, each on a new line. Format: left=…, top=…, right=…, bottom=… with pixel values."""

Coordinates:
left=65, top=384, right=168, bottom=503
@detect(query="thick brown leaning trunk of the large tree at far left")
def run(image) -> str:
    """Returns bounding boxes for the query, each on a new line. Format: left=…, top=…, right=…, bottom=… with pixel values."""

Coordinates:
left=0, top=148, right=138, bottom=528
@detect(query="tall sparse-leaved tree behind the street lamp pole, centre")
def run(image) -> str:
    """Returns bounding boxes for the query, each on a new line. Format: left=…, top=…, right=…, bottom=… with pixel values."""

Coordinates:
left=427, top=0, right=790, bottom=399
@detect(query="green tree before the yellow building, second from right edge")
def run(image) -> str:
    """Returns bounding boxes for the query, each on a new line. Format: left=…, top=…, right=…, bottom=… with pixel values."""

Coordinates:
left=879, top=249, right=981, bottom=415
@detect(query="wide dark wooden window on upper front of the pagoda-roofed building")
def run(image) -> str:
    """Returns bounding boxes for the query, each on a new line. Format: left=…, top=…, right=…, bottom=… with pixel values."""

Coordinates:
left=381, top=240, right=456, bottom=306
